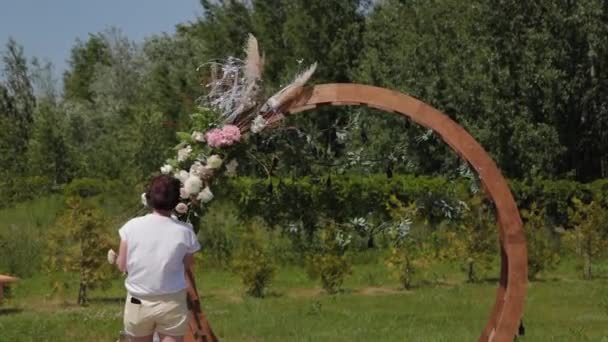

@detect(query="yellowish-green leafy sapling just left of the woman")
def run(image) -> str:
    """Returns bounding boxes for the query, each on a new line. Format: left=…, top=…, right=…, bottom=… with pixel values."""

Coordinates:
left=46, top=193, right=113, bottom=305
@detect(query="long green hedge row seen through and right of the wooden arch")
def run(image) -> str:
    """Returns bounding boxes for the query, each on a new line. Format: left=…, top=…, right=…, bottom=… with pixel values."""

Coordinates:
left=217, top=175, right=608, bottom=226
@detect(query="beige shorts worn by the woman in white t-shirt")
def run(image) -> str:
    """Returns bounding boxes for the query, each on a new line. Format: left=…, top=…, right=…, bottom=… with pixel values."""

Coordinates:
left=124, top=290, right=189, bottom=337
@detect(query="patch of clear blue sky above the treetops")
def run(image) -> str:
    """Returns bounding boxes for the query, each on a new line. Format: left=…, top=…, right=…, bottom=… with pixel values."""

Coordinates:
left=0, top=0, right=202, bottom=75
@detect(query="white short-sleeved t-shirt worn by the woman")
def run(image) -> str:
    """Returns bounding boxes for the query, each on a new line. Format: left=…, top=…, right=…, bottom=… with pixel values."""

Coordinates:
left=118, top=214, right=201, bottom=296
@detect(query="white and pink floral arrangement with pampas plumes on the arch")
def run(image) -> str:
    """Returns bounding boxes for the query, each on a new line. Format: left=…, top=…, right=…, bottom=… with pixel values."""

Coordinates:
left=142, top=35, right=316, bottom=223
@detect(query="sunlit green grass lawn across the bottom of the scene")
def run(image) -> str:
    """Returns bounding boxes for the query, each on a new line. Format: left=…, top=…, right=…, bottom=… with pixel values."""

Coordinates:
left=0, top=263, right=608, bottom=341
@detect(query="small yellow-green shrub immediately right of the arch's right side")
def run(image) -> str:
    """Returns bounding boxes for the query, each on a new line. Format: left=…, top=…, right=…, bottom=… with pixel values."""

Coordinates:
left=521, top=203, right=560, bottom=279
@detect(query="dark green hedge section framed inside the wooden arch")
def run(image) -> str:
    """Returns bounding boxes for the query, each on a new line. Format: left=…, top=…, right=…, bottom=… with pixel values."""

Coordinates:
left=222, top=174, right=466, bottom=236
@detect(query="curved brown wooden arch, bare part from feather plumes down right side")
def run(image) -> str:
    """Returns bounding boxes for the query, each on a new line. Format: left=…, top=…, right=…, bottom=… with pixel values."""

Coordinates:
left=283, top=84, right=528, bottom=341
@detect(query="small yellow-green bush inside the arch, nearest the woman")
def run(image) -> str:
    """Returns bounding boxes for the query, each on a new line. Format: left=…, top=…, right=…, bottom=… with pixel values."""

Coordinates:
left=232, top=220, right=276, bottom=297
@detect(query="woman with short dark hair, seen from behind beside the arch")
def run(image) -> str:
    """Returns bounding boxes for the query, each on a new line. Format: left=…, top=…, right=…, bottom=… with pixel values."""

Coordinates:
left=110, top=175, right=200, bottom=342
